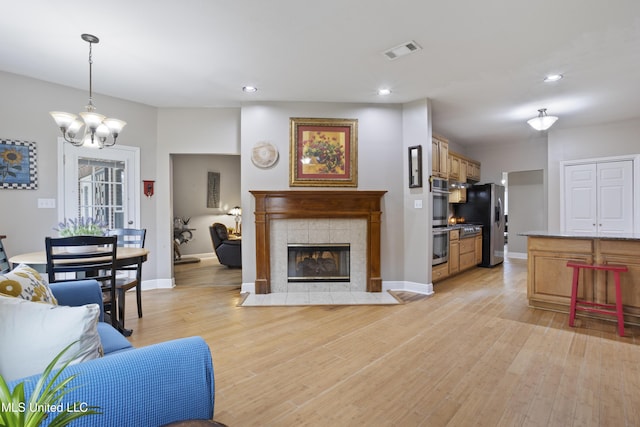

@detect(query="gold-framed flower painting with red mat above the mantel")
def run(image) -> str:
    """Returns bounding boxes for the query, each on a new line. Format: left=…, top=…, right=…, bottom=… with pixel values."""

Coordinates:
left=289, top=117, right=358, bottom=187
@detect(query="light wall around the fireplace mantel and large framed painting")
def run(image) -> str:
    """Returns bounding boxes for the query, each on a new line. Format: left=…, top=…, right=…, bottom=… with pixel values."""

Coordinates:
left=241, top=102, right=405, bottom=284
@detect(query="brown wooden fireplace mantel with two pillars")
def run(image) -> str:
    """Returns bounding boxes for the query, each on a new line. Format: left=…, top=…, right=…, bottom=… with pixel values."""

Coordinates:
left=250, top=190, right=386, bottom=294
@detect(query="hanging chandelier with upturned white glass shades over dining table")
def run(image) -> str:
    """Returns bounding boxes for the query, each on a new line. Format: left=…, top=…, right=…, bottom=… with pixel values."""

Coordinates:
left=49, top=34, right=127, bottom=148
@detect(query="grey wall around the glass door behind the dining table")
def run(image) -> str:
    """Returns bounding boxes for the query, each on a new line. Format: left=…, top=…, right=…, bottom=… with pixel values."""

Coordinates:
left=0, top=72, right=156, bottom=278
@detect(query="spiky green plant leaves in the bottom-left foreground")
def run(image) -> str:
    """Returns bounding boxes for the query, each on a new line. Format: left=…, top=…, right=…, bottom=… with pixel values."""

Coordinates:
left=0, top=341, right=101, bottom=427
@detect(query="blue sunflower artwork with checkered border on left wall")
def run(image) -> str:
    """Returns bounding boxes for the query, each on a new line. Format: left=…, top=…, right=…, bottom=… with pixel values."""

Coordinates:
left=0, top=139, right=38, bottom=190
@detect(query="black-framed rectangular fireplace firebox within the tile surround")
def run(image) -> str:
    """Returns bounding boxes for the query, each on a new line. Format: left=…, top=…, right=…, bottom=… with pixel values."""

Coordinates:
left=287, top=243, right=351, bottom=282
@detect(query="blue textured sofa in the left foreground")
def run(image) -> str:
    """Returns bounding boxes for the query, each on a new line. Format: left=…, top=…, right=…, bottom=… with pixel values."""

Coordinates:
left=8, top=280, right=215, bottom=427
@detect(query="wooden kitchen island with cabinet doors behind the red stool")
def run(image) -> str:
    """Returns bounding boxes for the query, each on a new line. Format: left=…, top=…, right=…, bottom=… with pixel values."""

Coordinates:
left=521, top=231, right=640, bottom=325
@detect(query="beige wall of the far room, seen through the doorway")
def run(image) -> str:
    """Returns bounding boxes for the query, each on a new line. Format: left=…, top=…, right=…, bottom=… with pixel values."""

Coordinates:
left=172, top=154, right=240, bottom=255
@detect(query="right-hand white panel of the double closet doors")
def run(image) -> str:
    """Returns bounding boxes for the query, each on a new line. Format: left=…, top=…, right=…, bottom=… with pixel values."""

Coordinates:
left=597, top=160, right=633, bottom=233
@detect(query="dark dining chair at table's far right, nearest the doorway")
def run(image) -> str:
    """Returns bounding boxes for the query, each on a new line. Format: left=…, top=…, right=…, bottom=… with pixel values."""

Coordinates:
left=106, top=228, right=147, bottom=328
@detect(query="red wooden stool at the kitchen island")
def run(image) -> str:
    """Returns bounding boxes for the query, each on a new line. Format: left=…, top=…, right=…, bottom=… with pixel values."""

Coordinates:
left=567, top=261, right=629, bottom=337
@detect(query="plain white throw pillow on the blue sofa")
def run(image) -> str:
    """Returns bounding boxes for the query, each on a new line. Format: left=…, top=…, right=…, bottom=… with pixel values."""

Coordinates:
left=0, top=295, right=101, bottom=381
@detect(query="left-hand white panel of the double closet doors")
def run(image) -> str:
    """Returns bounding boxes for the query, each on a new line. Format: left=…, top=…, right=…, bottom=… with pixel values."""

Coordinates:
left=564, top=163, right=597, bottom=232
